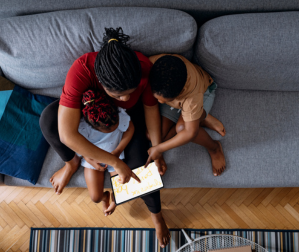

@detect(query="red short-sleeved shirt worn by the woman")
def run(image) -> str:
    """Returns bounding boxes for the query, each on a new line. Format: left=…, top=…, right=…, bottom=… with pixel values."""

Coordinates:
left=59, top=52, right=157, bottom=109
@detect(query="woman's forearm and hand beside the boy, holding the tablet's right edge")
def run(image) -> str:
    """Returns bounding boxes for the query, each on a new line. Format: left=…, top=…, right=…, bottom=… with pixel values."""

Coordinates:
left=143, top=104, right=167, bottom=175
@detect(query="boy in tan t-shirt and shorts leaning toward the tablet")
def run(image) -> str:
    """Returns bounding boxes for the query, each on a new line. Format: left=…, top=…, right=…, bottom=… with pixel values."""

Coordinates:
left=146, top=54, right=226, bottom=176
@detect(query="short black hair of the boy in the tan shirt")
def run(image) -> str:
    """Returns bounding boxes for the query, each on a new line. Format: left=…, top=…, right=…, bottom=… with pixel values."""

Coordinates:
left=149, top=55, right=187, bottom=98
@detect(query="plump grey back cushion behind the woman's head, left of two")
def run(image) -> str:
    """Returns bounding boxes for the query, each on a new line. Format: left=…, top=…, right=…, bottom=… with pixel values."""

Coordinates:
left=0, top=7, right=197, bottom=89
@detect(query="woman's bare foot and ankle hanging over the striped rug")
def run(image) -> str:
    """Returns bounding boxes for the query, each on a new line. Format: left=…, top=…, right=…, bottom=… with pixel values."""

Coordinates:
left=151, top=212, right=170, bottom=248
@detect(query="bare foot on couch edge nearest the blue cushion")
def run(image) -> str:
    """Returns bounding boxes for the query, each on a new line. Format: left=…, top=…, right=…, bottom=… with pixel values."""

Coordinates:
left=50, top=155, right=81, bottom=195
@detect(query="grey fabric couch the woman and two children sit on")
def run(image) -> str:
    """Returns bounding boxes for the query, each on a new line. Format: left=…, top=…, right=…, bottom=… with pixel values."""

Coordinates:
left=0, top=3, right=299, bottom=188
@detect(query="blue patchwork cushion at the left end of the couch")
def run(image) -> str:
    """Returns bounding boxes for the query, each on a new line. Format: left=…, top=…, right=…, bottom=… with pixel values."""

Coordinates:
left=0, top=77, right=55, bottom=184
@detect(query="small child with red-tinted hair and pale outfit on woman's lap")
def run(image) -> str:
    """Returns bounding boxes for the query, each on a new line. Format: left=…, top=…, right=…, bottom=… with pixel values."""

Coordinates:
left=78, top=90, right=134, bottom=216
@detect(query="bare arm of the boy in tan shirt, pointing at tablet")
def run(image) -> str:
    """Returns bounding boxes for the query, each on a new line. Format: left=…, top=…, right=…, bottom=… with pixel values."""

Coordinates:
left=145, top=119, right=200, bottom=167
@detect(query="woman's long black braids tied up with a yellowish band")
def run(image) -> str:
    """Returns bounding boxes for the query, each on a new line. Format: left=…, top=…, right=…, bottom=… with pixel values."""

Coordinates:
left=94, top=27, right=141, bottom=92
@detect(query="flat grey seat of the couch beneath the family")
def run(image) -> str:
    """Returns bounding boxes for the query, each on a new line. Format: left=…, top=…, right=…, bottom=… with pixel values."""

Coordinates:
left=5, top=88, right=299, bottom=188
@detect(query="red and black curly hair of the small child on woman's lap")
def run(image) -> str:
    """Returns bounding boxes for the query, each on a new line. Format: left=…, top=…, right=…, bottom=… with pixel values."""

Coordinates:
left=82, top=90, right=119, bottom=129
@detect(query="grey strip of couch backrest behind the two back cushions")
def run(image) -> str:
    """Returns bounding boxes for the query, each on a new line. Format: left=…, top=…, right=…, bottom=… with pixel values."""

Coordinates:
left=0, top=0, right=299, bottom=25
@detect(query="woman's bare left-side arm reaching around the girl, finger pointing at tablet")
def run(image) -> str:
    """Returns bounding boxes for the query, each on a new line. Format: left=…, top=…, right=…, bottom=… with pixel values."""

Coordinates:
left=58, top=105, right=140, bottom=184
